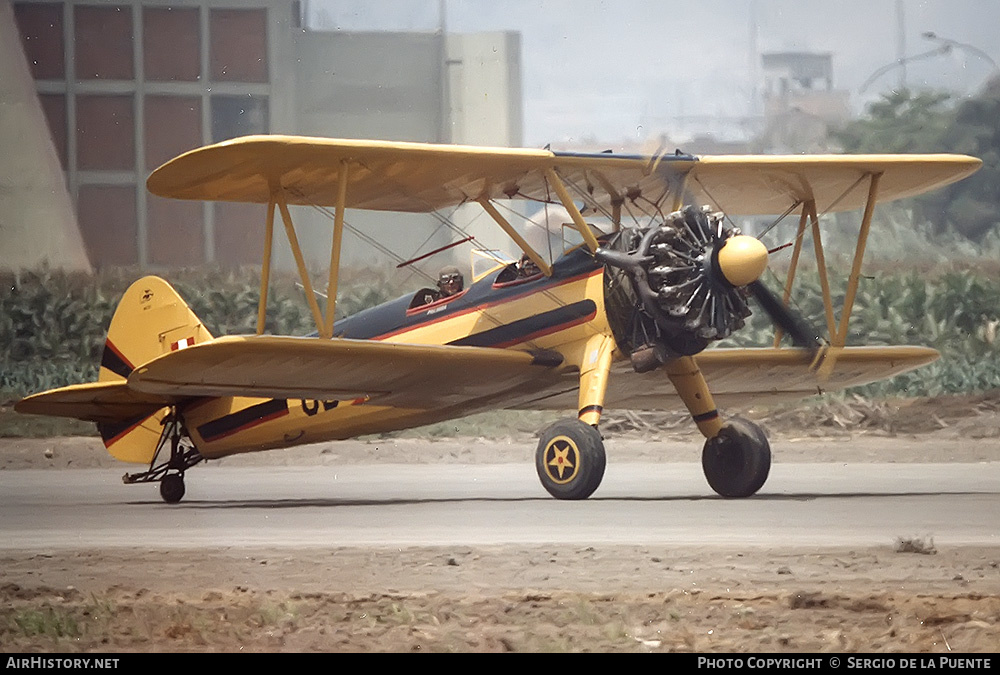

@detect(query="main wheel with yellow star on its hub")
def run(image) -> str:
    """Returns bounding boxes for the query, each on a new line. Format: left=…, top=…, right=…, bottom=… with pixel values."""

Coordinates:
left=535, top=419, right=607, bottom=499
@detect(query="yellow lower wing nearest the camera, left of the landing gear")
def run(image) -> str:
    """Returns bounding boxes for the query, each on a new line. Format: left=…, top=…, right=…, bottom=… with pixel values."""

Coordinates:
left=128, top=336, right=575, bottom=409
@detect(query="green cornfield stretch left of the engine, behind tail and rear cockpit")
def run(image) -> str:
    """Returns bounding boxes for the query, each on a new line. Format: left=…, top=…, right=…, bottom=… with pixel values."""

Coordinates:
left=0, top=268, right=402, bottom=402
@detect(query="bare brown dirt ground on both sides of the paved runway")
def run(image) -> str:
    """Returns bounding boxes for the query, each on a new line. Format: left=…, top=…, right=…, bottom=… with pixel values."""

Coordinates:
left=0, top=393, right=1000, bottom=652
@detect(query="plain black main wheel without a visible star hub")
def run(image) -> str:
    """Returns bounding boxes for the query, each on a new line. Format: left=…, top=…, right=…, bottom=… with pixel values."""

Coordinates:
left=701, top=417, right=771, bottom=497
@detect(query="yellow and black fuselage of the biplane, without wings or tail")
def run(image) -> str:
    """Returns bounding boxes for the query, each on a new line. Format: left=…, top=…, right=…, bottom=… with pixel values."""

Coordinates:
left=181, top=249, right=611, bottom=458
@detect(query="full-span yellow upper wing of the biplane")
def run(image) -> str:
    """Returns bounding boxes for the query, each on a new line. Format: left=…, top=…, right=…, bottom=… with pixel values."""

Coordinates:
left=147, top=136, right=982, bottom=214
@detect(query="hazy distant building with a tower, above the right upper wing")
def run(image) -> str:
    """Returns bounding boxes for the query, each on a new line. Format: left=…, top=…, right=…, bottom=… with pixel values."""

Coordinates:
left=758, top=52, right=851, bottom=153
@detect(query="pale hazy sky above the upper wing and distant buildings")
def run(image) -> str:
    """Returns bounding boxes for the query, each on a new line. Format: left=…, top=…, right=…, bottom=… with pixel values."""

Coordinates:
left=308, top=0, right=1000, bottom=146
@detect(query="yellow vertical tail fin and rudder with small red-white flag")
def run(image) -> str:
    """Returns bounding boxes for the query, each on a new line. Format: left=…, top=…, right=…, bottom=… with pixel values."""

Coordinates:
left=97, top=276, right=212, bottom=463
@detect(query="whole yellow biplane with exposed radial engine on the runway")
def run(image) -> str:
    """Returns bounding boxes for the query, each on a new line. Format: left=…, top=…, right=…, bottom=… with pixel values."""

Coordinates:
left=16, top=136, right=981, bottom=503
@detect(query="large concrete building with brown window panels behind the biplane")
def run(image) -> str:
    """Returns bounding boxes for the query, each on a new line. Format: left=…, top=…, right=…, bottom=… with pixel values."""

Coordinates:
left=0, top=0, right=521, bottom=270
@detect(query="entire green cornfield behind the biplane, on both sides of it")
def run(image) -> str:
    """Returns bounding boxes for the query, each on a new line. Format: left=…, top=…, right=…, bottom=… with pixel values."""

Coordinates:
left=0, top=256, right=1000, bottom=403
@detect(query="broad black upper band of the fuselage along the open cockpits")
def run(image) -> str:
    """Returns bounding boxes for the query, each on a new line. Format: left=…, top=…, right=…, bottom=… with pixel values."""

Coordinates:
left=333, top=249, right=600, bottom=340
